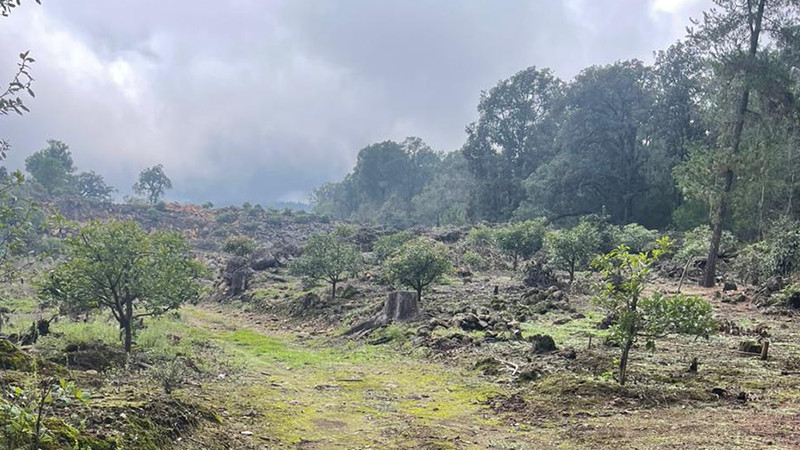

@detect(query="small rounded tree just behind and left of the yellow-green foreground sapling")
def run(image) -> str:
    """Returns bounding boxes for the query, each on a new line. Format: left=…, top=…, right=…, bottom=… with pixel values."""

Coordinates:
left=545, top=222, right=600, bottom=283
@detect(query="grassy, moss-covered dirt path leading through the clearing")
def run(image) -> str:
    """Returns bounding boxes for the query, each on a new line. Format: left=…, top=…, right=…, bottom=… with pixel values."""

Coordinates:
left=180, top=307, right=552, bottom=449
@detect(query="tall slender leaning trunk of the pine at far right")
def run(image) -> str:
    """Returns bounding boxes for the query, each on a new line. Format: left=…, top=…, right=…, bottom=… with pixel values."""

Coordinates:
left=700, top=0, right=767, bottom=287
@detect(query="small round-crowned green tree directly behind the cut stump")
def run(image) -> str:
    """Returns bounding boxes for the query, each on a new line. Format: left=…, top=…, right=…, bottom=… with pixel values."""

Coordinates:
left=384, top=237, right=452, bottom=301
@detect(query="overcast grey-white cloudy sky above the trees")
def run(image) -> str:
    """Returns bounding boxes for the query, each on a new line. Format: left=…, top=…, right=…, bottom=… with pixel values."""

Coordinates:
left=0, top=0, right=711, bottom=205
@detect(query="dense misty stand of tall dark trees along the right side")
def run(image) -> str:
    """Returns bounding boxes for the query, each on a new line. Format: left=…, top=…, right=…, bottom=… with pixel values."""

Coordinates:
left=312, top=0, right=800, bottom=278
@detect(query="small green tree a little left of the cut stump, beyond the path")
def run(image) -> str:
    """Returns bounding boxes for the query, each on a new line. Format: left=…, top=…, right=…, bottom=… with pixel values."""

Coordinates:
left=289, top=233, right=361, bottom=300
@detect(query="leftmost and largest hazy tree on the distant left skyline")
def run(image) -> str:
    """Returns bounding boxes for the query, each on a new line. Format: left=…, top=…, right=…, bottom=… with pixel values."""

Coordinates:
left=25, top=139, right=76, bottom=195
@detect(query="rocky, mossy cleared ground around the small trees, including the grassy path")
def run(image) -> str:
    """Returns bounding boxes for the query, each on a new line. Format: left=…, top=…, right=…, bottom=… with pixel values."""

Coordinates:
left=0, top=205, right=800, bottom=449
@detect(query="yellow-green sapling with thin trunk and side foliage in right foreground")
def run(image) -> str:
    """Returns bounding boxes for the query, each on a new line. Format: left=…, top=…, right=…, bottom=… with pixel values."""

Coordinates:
left=592, top=237, right=715, bottom=384
